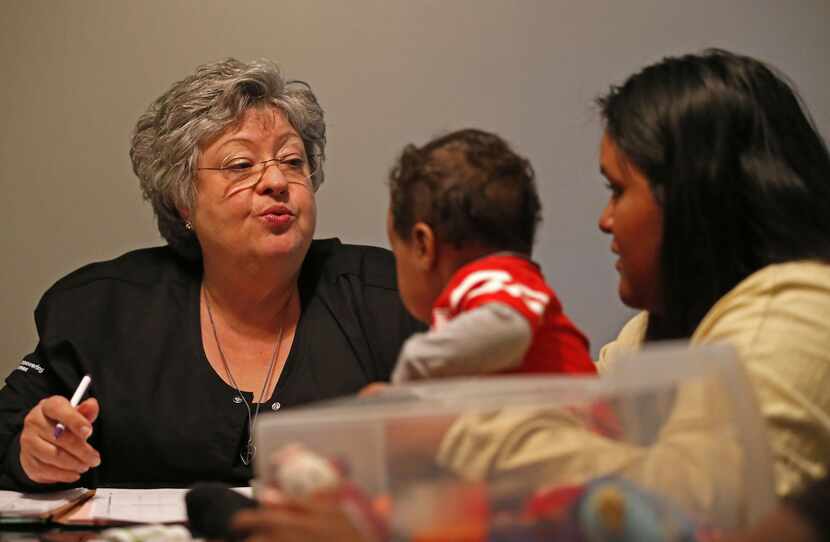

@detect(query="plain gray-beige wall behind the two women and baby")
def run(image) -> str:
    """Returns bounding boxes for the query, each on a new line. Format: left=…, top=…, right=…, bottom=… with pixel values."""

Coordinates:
left=0, top=0, right=830, bottom=374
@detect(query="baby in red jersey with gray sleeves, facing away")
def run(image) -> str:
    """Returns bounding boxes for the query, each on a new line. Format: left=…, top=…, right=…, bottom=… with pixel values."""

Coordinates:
left=387, top=129, right=596, bottom=383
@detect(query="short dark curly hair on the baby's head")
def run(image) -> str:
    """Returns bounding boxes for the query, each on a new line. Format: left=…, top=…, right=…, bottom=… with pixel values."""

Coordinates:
left=389, top=129, right=542, bottom=255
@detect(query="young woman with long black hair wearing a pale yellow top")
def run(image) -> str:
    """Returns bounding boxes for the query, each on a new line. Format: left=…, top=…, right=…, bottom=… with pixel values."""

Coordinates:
left=599, top=50, right=830, bottom=502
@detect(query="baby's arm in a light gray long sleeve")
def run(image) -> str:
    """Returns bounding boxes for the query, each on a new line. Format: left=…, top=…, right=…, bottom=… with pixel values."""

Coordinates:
left=392, top=302, right=533, bottom=384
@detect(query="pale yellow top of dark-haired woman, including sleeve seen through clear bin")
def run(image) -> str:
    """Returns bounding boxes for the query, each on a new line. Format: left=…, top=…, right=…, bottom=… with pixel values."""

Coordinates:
left=438, top=262, right=830, bottom=526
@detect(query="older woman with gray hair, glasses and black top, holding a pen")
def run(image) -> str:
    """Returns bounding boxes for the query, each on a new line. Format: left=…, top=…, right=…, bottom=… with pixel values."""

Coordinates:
left=0, top=59, right=419, bottom=490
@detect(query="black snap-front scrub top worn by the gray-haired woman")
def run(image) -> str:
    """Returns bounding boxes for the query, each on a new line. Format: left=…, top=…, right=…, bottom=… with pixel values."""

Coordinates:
left=0, top=239, right=423, bottom=491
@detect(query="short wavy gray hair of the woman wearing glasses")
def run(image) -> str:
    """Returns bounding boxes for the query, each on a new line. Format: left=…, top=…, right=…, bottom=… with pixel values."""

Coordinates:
left=130, top=58, right=326, bottom=260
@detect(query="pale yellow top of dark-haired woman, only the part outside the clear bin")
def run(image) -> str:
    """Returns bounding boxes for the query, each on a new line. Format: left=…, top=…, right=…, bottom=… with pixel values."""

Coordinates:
left=597, top=262, right=830, bottom=496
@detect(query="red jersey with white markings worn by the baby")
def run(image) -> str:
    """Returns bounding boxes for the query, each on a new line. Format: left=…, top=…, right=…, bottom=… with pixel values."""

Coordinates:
left=432, top=253, right=596, bottom=374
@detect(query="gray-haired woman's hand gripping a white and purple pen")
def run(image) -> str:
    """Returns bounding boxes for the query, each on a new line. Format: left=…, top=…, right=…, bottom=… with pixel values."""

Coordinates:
left=20, top=395, right=101, bottom=484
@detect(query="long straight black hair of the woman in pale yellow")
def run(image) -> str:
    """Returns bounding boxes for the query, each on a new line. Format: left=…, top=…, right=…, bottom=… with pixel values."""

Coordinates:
left=598, top=49, right=830, bottom=340
